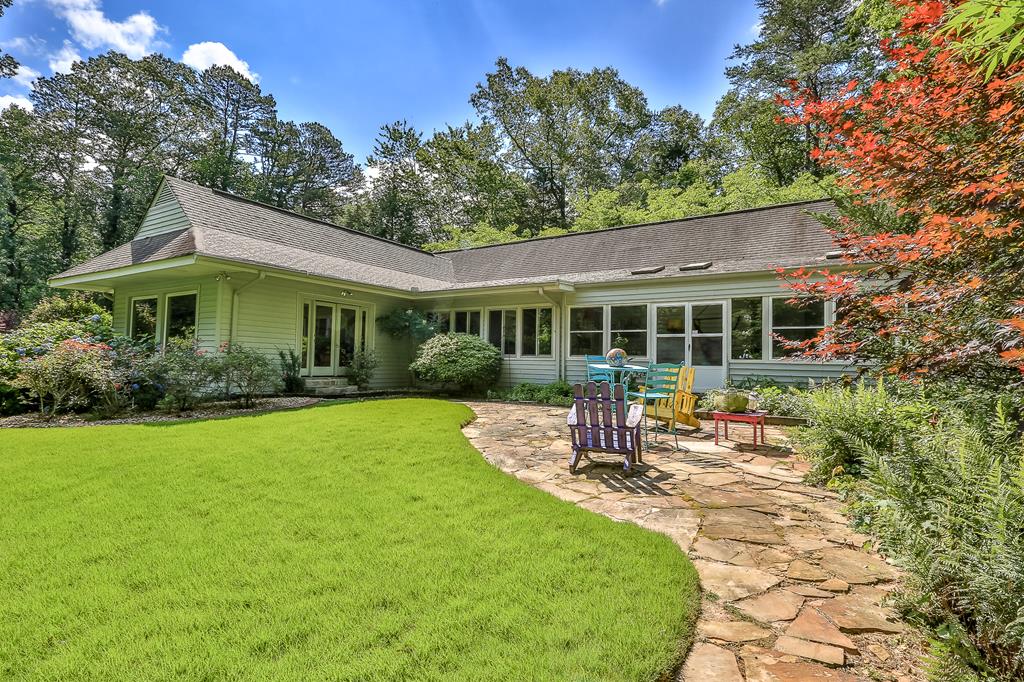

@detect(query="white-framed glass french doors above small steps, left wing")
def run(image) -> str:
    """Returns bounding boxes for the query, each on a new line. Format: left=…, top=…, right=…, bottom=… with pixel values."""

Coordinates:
left=302, top=301, right=364, bottom=377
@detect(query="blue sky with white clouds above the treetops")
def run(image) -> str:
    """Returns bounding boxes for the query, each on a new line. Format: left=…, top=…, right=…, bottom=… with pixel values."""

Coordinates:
left=0, top=0, right=758, bottom=163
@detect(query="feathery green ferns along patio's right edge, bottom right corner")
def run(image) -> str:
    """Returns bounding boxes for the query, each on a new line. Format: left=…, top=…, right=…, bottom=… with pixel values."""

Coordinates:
left=851, top=409, right=1024, bottom=681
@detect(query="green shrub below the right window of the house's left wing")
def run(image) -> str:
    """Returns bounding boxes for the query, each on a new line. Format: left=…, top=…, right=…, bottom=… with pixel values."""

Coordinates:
left=146, top=339, right=222, bottom=412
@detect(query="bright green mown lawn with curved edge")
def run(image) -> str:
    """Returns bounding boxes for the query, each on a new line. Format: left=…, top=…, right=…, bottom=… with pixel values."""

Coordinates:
left=0, top=399, right=697, bottom=680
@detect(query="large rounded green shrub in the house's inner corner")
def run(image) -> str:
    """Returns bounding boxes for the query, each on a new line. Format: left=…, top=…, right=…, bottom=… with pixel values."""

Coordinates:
left=410, top=334, right=502, bottom=392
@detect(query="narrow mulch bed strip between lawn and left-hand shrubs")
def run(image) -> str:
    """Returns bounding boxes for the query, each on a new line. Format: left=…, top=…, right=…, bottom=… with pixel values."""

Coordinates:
left=0, top=395, right=321, bottom=429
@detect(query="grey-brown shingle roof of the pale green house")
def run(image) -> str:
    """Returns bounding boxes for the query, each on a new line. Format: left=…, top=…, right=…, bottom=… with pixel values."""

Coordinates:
left=56, top=177, right=835, bottom=292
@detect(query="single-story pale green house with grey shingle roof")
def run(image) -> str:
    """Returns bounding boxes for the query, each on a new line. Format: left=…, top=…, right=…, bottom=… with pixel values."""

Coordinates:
left=50, top=177, right=847, bottom=390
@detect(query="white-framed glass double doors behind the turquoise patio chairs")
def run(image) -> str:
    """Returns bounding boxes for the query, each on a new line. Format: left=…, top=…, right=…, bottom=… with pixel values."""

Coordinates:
left=654, top=301, right=726, bottom=391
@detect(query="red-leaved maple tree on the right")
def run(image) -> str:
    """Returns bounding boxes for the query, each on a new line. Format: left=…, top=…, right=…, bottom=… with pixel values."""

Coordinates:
left=781, top=0, right=1024, bottom=385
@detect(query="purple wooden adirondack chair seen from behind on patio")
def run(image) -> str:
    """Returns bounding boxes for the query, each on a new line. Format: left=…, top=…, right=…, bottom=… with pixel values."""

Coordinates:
left=565, top=381, right=643, bottom=473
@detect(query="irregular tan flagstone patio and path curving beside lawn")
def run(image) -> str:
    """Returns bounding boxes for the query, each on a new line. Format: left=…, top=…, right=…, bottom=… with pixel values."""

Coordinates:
left=464, top=402, right=923, bottom=682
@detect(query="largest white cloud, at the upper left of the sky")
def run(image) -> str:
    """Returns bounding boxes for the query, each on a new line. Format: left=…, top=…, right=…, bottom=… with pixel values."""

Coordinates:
left=47, top=0, right=163, bottom=59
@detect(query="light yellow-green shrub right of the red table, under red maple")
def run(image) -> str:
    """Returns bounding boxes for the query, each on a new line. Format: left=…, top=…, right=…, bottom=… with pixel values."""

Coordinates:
left=795, top=380, right=935, bottom=481
